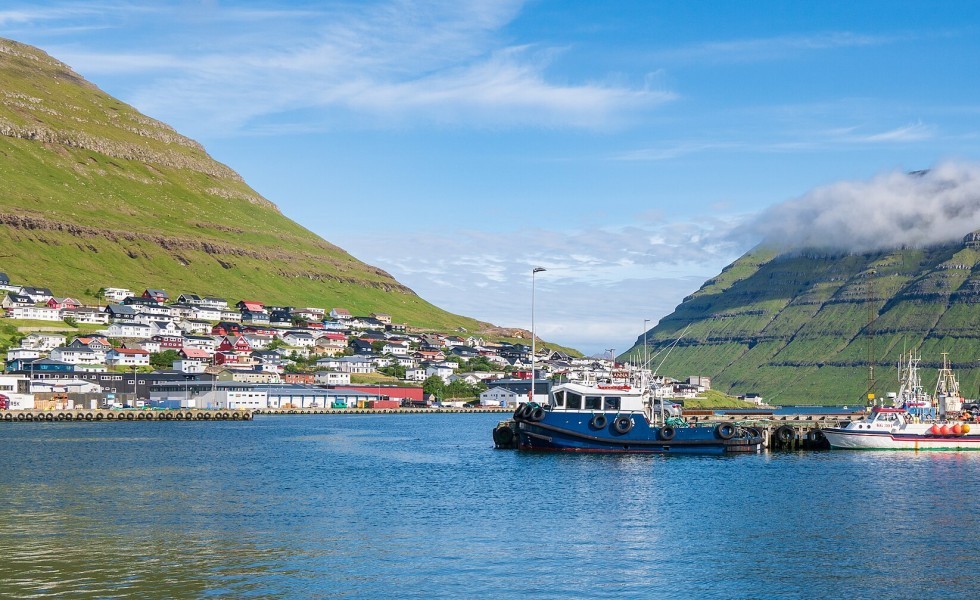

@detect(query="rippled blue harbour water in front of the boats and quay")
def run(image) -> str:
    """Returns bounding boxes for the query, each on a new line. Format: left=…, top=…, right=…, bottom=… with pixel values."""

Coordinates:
left=0, top=414, right=980, bottom=598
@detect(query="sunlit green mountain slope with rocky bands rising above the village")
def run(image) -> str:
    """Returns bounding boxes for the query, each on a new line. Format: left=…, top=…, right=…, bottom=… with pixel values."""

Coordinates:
left=0, top=39, right=489, bottom=331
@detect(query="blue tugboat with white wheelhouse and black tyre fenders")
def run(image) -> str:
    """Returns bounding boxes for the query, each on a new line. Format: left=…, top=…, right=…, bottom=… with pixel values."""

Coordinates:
left=493, top=383, right=762, bottom=454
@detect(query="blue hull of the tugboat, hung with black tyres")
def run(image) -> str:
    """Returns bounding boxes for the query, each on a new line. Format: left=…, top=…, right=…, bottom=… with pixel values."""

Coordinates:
left=517, top=411, right=762, bottom=454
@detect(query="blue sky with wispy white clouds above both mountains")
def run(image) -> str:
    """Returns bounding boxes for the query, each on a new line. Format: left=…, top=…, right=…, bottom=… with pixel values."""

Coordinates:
left=0, top=0, right=980, bottom=353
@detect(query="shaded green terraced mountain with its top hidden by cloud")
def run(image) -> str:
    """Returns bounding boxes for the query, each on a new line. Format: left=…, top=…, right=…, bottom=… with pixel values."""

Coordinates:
left=626, top=234, right=980, bottom=404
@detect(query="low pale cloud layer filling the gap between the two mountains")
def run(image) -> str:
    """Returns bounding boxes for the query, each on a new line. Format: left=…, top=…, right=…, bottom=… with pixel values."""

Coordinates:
left=333, top=217, right=746, bottom=354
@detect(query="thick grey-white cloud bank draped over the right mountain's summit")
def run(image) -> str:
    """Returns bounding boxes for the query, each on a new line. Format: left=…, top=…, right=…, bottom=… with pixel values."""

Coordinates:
left=733, top=162, right=980, bottom=252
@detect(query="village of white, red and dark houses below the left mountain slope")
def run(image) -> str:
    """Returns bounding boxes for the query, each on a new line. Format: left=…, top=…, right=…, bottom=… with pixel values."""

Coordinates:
left=0, top=273, right=710, bottom=410
